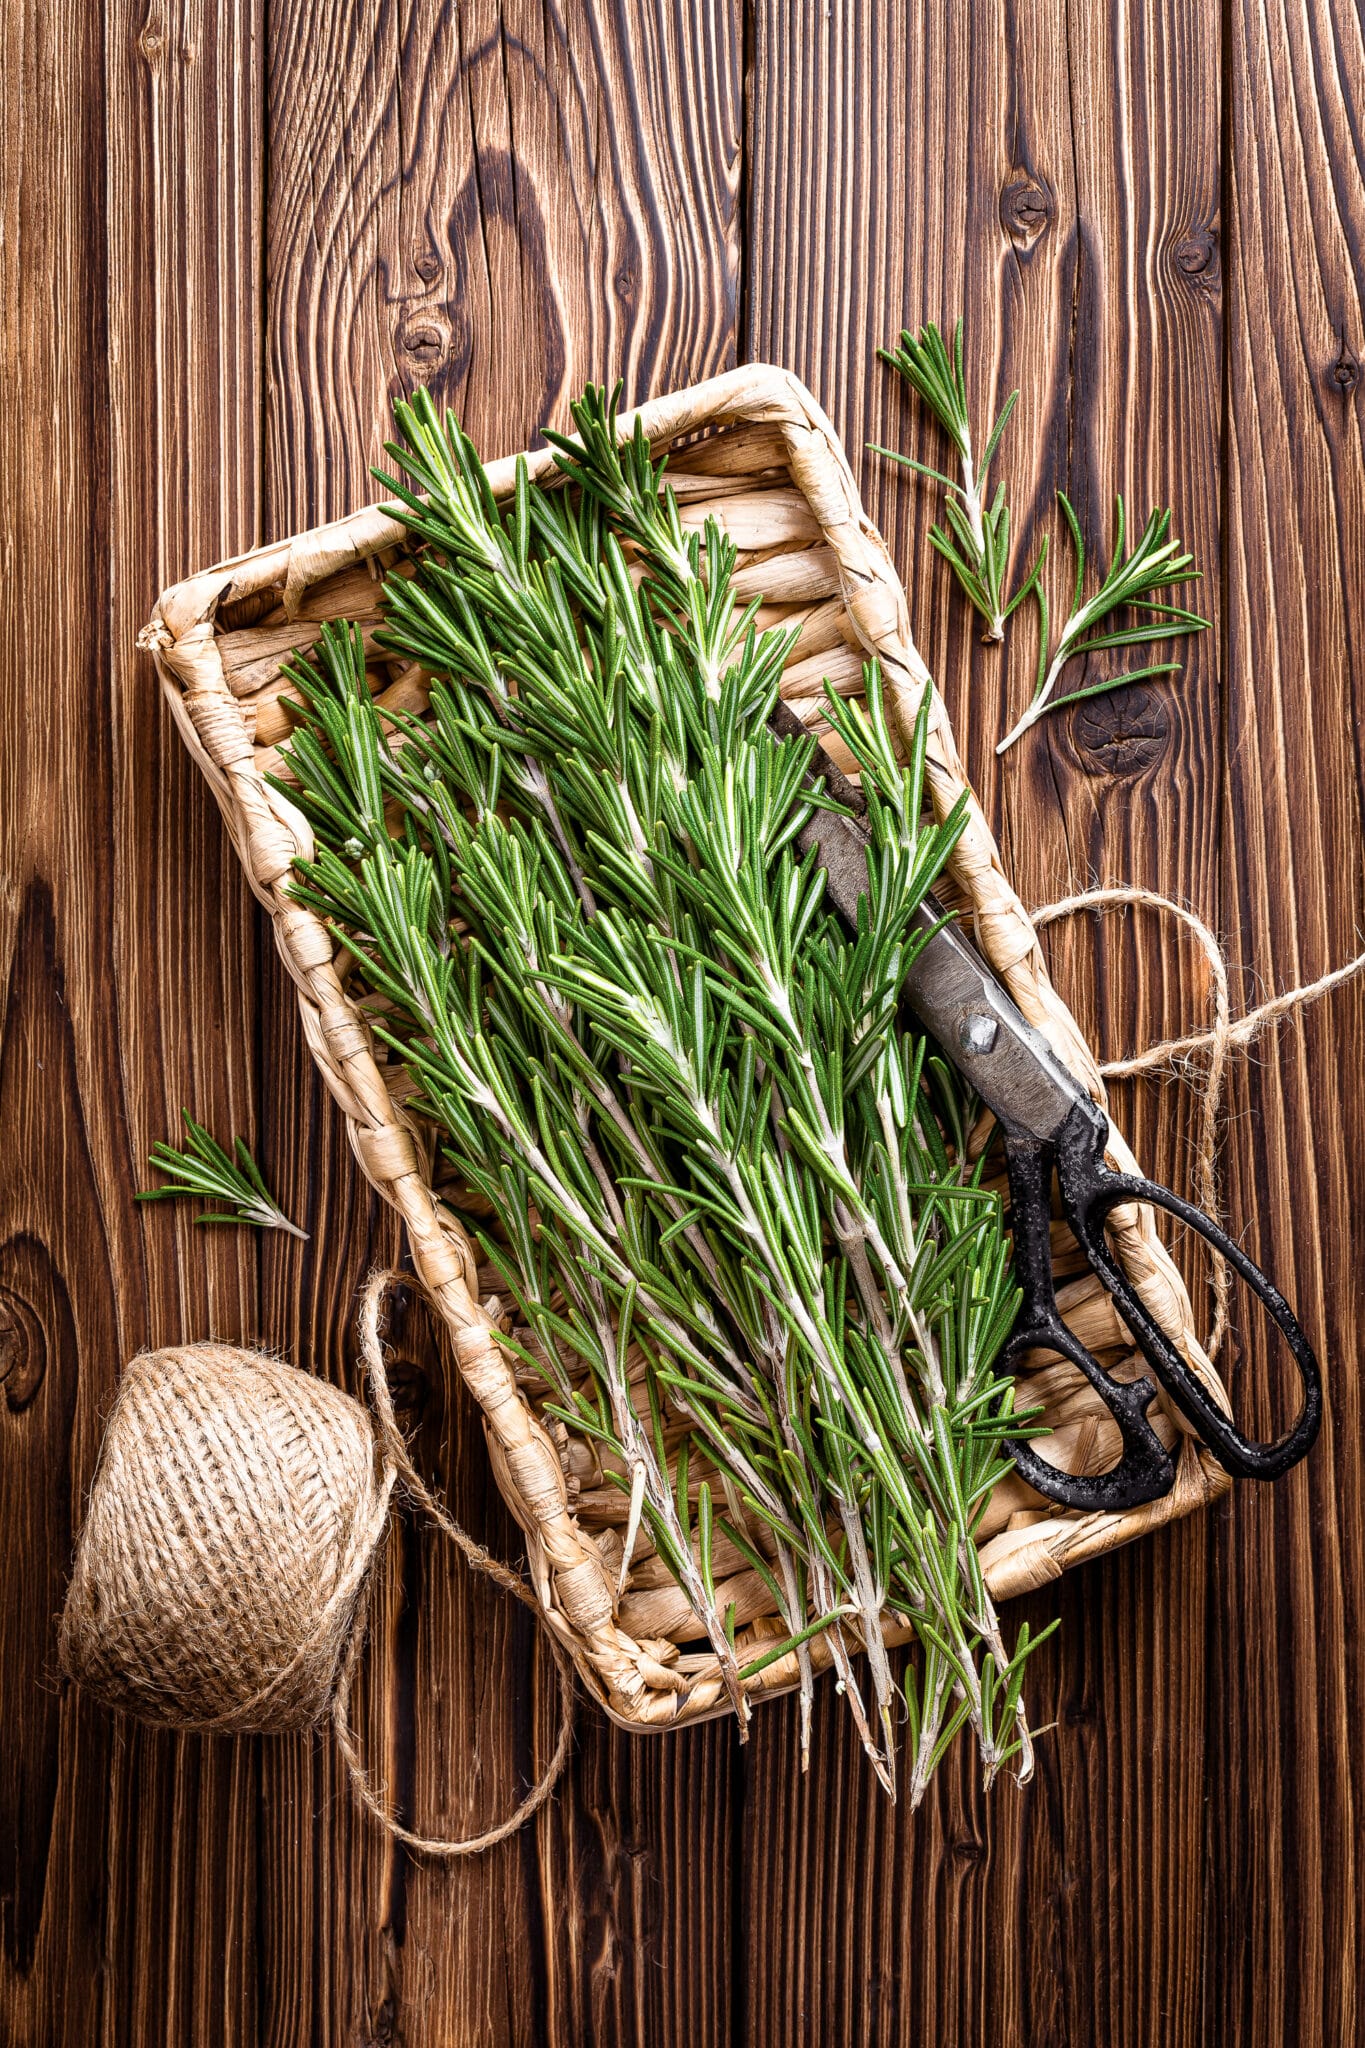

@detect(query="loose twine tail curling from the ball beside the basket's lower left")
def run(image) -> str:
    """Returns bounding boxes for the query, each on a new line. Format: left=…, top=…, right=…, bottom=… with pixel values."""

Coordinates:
left=332, top=1268, right=573, bottom=1860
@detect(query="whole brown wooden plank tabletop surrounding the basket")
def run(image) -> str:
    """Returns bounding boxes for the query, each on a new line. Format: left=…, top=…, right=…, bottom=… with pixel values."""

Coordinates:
left=0, top=0, right=1365, bottom=2048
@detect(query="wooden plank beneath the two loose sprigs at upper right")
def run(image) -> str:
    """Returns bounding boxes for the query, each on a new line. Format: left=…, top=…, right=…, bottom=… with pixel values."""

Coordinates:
left=745, top=4, right=1220, bottom=2042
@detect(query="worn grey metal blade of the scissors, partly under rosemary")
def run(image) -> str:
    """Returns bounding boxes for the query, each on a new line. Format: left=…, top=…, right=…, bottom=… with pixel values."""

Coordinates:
left=769, top=705, right=1091, bottom=1141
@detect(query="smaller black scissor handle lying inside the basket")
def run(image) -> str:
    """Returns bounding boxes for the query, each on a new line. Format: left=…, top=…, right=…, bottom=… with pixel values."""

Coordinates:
left=1001, top=1139, right=1175, bottom=1511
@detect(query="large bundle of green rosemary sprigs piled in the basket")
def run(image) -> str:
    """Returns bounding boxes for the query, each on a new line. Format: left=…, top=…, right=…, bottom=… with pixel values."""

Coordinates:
left=280, top=389, right=1038, bottom=1800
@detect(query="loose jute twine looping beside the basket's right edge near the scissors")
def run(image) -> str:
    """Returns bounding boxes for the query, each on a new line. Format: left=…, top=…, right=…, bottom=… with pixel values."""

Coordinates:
left=1029, top=885, right=1365, bottom=1360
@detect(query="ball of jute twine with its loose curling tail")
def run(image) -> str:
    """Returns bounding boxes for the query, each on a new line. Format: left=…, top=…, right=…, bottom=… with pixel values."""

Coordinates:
left=57, top=1272, right=573, bottom=1855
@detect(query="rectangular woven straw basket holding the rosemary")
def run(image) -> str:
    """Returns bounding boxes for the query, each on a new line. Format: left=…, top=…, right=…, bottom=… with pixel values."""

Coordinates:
left=141, top=365, right=1228, bottom=1729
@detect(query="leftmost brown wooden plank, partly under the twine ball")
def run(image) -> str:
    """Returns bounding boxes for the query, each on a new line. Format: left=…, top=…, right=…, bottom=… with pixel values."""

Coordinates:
left=0, top=0, right=262, bottom=2044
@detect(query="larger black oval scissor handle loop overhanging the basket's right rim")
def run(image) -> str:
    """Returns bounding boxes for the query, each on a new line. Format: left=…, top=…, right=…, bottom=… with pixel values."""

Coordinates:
left=1056, top=1104, right=1322, bottom=1479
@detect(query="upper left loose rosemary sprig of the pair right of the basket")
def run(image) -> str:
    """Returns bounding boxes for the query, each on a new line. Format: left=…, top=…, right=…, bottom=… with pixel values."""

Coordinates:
left=868, top=322, right=1048, bottom=641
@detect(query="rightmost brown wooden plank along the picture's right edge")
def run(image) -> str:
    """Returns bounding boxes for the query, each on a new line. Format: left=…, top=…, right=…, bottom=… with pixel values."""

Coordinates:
left=1205, top=4, right=1365, bottom=2042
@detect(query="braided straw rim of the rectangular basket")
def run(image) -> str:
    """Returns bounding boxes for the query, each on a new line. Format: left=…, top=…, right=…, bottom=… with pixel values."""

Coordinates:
left=139, top=365, right=1230, bottom=1731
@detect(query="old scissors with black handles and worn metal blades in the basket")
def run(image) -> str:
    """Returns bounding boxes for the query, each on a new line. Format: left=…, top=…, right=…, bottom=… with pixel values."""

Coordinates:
left=769, top=705, right=1322, bottom=1509
